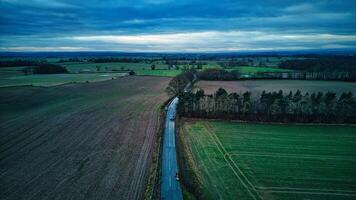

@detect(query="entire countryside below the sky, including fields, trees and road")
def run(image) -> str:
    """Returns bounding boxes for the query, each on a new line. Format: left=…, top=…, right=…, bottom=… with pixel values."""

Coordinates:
left=0, top=54, right=356, bottom=200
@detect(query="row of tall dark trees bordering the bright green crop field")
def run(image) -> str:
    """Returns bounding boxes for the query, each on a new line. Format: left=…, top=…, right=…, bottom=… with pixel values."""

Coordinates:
left=178, top=88, right=356, bottom=123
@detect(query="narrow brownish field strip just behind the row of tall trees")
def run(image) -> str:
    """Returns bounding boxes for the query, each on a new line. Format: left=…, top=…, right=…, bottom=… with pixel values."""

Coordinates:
left=196, top=80, right=356, bottom=94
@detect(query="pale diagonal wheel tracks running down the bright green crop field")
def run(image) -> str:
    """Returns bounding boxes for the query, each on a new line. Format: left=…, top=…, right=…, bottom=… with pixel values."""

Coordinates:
left=203, top=122, right=263, bottom=200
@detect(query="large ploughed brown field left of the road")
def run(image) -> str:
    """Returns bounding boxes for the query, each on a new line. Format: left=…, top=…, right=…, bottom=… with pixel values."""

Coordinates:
left=0, top=76, right=170, bottom=200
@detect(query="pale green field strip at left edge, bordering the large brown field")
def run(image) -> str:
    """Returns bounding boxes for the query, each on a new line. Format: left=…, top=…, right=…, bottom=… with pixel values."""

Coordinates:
left=0, top=73, right=126, bottom=87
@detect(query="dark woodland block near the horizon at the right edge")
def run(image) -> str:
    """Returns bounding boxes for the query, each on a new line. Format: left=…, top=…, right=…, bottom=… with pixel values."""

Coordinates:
left=279, top=56, right=356, bottom=73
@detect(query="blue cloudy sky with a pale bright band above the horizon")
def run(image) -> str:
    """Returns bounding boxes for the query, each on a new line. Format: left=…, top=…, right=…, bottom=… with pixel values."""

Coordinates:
left=0, top=0, right=356, bottom=52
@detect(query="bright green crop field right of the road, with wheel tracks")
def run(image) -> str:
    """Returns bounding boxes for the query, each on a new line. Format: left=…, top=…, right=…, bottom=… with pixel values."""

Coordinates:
left=180, top=120, right=356, bottom=200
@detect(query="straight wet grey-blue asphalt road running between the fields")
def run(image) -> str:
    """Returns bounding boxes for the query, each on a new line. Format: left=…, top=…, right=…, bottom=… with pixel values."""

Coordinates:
left=161, top=97, right=183, bottom=200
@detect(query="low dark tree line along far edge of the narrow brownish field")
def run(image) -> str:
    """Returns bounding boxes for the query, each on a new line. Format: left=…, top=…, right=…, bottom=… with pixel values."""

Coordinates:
left=197, top=69, right=356, bottom=81
